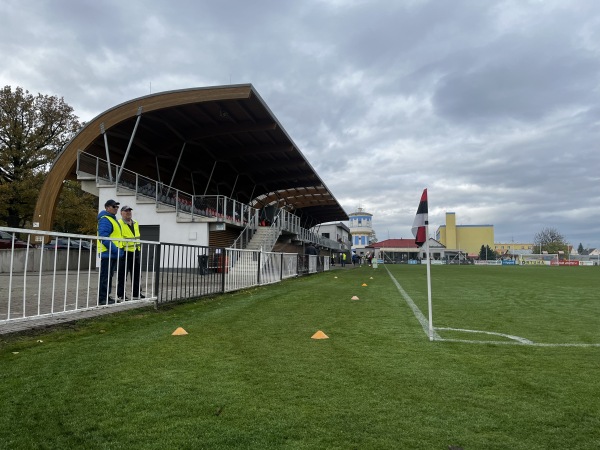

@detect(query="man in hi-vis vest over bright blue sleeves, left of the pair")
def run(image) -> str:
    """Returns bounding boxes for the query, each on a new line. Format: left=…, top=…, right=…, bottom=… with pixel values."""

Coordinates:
left=98, top=200, right=123, bottom=305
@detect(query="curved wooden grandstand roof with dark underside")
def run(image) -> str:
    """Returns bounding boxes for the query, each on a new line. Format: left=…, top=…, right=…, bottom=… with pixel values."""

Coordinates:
left=33, top=84, right=348, bottom=230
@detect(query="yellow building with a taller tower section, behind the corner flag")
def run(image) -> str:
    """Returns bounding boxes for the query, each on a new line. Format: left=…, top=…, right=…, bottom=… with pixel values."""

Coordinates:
left=435, top=213, right=494, bottom=256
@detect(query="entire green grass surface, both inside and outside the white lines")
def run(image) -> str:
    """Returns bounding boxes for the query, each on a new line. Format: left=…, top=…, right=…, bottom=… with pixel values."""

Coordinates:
left=0, top=265, right=600, bottom=449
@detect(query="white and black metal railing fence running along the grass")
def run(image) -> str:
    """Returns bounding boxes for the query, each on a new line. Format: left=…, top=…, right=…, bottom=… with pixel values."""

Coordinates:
left=0, top=227, right=329, bottom=327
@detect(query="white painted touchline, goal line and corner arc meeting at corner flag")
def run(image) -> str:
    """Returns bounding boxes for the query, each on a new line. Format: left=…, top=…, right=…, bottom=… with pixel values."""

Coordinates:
left=383, top=265, right=600, bottom=348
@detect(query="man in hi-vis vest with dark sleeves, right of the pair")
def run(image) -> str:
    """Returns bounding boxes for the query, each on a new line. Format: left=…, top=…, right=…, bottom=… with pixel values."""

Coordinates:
left=117, top=205, right=145, bottom=300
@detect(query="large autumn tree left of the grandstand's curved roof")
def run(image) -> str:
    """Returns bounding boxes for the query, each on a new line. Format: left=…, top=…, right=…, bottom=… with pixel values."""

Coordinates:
left=0, top=86, right=80, bottom=228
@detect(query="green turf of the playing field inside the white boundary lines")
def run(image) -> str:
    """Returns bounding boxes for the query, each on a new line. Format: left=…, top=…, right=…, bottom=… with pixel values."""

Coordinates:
left=387, top=266, right=600, bottom=344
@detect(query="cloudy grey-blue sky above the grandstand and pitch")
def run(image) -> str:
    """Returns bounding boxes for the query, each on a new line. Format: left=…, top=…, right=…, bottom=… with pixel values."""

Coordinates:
left=0, top=0, right=600, bottom=247
